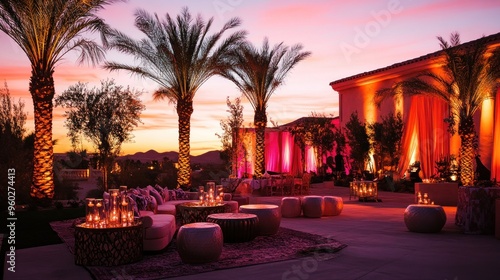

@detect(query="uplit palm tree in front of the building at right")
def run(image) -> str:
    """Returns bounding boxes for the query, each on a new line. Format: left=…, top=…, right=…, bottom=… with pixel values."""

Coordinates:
left=375, top=33, right=500, bottom=186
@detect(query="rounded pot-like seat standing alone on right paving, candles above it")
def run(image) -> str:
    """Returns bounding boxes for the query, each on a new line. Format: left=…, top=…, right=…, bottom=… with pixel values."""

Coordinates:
left=404, top=204, right=446, bottom=233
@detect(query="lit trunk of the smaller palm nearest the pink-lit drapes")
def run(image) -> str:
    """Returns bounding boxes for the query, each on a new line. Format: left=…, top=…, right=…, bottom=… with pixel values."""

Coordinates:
left=254, top=109, right=267, bottom=178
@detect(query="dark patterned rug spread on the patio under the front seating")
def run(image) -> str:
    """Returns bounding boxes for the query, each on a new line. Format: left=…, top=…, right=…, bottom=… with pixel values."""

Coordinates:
left=50, top=220, right=347, bottom=280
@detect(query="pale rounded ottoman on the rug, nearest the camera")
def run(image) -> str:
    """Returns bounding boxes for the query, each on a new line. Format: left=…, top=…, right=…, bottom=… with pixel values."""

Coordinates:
left=177, top=222, right=223, bottom=264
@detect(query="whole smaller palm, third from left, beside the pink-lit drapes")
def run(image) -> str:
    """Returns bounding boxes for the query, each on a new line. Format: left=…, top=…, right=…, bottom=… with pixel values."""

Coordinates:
left=223, top=38, right=311, bottom=177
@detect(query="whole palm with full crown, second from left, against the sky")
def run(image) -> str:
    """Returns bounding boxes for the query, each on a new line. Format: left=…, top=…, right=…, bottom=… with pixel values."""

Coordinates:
left=105, top=8, right=246, bottom=187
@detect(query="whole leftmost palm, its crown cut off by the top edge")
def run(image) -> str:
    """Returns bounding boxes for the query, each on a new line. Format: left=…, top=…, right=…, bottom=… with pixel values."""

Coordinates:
left=0, top=0, right=117, bottom=199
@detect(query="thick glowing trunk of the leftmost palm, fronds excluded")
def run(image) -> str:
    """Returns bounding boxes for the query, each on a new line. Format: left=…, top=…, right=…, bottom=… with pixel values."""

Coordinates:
left=29, top=70, right=55, bottom=199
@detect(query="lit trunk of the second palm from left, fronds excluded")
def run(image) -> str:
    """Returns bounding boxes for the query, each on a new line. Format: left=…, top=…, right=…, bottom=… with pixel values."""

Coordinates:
left=177, top=100, right=193, bottom=188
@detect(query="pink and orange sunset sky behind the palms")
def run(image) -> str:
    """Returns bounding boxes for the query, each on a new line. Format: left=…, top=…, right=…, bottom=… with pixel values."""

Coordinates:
left=0, top=0, right=500, bottom=155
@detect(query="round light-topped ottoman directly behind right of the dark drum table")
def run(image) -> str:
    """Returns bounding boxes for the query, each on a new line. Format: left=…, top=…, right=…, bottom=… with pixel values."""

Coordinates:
left=240, top=204, right=281, bottom=235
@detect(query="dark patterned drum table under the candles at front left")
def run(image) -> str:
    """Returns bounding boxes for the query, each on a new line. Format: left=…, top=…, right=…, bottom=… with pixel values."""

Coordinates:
left=75, top=221, right=144, bottom=266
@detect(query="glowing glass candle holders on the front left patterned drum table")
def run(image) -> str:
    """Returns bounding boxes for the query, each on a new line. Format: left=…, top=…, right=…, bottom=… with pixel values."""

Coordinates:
left=85, top=186, right=134, bottom=228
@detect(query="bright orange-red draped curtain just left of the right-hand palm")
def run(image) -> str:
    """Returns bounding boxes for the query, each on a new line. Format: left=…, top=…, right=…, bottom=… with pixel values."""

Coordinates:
left=399, top=95, right=450, bottom=178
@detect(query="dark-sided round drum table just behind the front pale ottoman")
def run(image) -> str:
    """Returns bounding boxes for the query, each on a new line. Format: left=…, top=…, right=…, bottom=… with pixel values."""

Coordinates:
left=207, top=213, right=259, bottom=243
